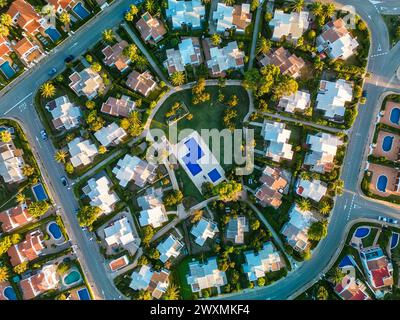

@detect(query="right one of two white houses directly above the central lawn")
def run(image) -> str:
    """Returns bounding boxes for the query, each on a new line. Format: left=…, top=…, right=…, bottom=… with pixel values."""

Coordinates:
left=203, top=38, right=245, bottom=77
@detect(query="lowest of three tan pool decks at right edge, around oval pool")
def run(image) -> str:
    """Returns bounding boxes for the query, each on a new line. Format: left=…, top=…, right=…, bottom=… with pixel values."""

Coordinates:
left=368, top=163, right=400, bottom=197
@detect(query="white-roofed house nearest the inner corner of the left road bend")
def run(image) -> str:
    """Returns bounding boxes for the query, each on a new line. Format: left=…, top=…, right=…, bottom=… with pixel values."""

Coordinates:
left=46, top=96, right=82, bottom=130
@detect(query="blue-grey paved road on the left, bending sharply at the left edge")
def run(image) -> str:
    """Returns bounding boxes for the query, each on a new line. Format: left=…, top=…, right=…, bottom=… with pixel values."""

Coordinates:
left=0, top=0, right=142, bottom=299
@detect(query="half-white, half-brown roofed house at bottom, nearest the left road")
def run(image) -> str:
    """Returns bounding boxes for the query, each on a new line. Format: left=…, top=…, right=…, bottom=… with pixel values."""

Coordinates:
left=129, top=265, right=169, bottom=299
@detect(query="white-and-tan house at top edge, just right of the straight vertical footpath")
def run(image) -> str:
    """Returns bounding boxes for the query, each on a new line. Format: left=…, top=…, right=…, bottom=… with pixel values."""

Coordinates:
left=269, top=9, right=309, bottom=44
